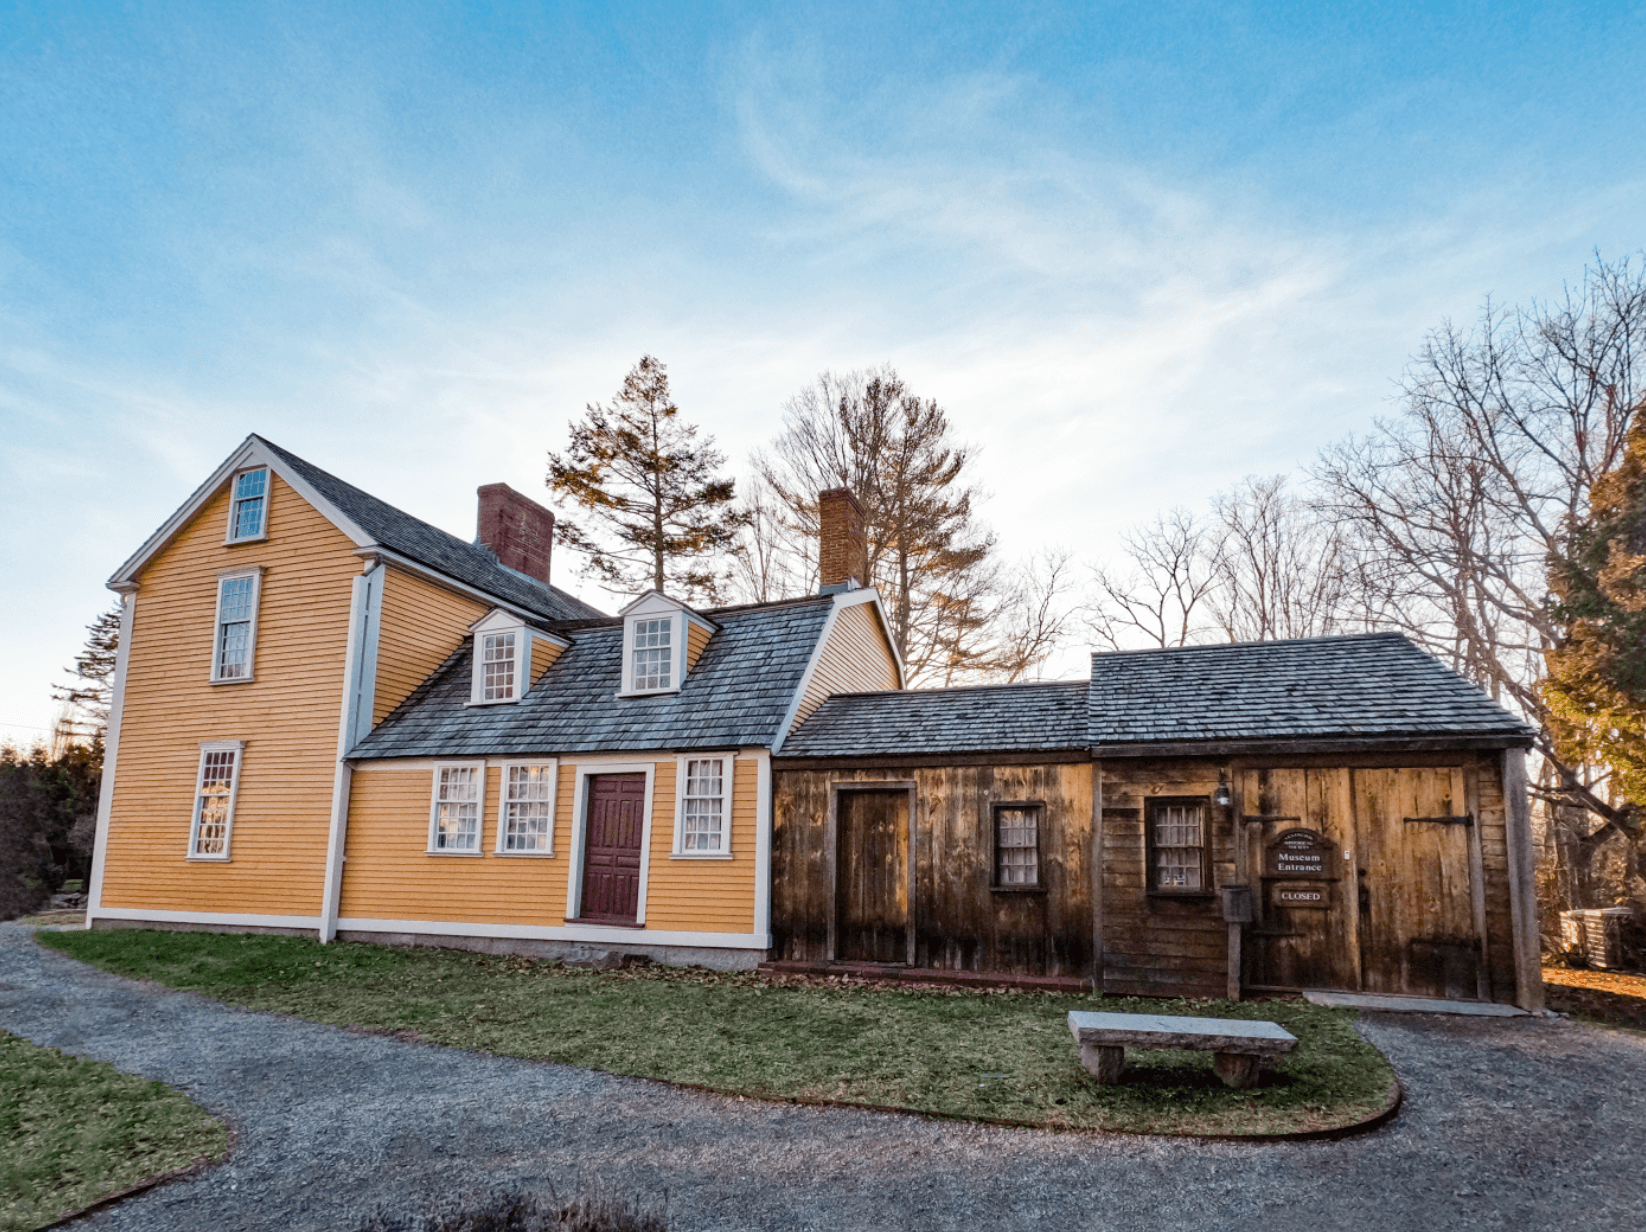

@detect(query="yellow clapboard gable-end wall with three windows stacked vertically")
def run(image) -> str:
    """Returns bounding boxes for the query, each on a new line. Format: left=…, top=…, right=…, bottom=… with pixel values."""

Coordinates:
left=102, top=474, right=360, bottom=916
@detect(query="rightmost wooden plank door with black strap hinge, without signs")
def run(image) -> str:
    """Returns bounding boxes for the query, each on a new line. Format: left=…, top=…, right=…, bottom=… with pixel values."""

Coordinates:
left=1353, top=768, right=1480, bottom=1000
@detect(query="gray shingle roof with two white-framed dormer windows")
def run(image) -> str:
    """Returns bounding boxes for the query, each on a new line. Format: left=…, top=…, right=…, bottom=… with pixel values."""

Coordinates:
left=351, top=596, right=833, bottom=758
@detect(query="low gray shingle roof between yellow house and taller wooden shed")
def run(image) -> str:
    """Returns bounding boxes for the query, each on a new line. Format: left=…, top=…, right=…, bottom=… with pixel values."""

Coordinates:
left=782, top=680, right=1088, bottom=758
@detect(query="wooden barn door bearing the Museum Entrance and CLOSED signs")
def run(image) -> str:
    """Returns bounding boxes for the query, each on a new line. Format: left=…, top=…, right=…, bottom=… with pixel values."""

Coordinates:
left=1241, top=769, right=1360, bottom=992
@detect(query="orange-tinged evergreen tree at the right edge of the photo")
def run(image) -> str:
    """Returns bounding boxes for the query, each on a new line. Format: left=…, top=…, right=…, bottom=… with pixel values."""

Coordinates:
left=1542, top=404, right=1646, bottom=807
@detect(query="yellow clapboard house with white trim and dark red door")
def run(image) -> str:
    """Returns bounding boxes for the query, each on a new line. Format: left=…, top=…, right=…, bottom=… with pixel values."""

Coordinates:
left=87, top=435, right=904, bottom=967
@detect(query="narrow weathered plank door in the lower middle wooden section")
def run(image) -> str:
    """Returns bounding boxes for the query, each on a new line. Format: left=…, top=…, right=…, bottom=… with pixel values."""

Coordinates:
left=835, top=791, right=909, bottom=962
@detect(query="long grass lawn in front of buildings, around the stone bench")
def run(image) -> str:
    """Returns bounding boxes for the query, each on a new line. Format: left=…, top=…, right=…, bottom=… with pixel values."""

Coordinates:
left=36, top=929, right=1394, bottom=1135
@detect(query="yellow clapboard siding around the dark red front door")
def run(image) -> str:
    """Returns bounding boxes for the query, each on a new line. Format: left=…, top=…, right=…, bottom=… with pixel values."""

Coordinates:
left=339, top=758, right=759, bottom=940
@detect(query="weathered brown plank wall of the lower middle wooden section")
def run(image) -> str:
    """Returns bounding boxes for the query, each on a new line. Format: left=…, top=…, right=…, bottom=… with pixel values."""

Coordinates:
left=772, top=763, right=1093, bottom=977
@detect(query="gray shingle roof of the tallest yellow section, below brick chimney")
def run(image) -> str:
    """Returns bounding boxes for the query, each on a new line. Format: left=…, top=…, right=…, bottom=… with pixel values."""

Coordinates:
left=258, top=436, right=606, bottom=621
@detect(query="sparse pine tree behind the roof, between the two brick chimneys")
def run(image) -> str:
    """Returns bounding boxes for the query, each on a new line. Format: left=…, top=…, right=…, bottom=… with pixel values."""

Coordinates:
left=548, top=356, right=746, bottom=601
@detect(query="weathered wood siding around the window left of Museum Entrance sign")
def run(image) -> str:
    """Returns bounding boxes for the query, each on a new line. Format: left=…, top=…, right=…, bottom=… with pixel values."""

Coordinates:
left=1101, top=759, right=1235, bottom=996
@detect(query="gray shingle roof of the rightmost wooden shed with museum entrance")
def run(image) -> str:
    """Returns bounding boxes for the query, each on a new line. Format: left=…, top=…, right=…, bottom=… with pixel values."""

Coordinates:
left=1091, top=632, right=1531, bottom=744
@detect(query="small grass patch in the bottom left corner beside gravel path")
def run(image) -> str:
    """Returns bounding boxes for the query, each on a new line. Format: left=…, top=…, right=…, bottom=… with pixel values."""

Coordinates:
left=0, top=1031, right=229, bottom=1232
